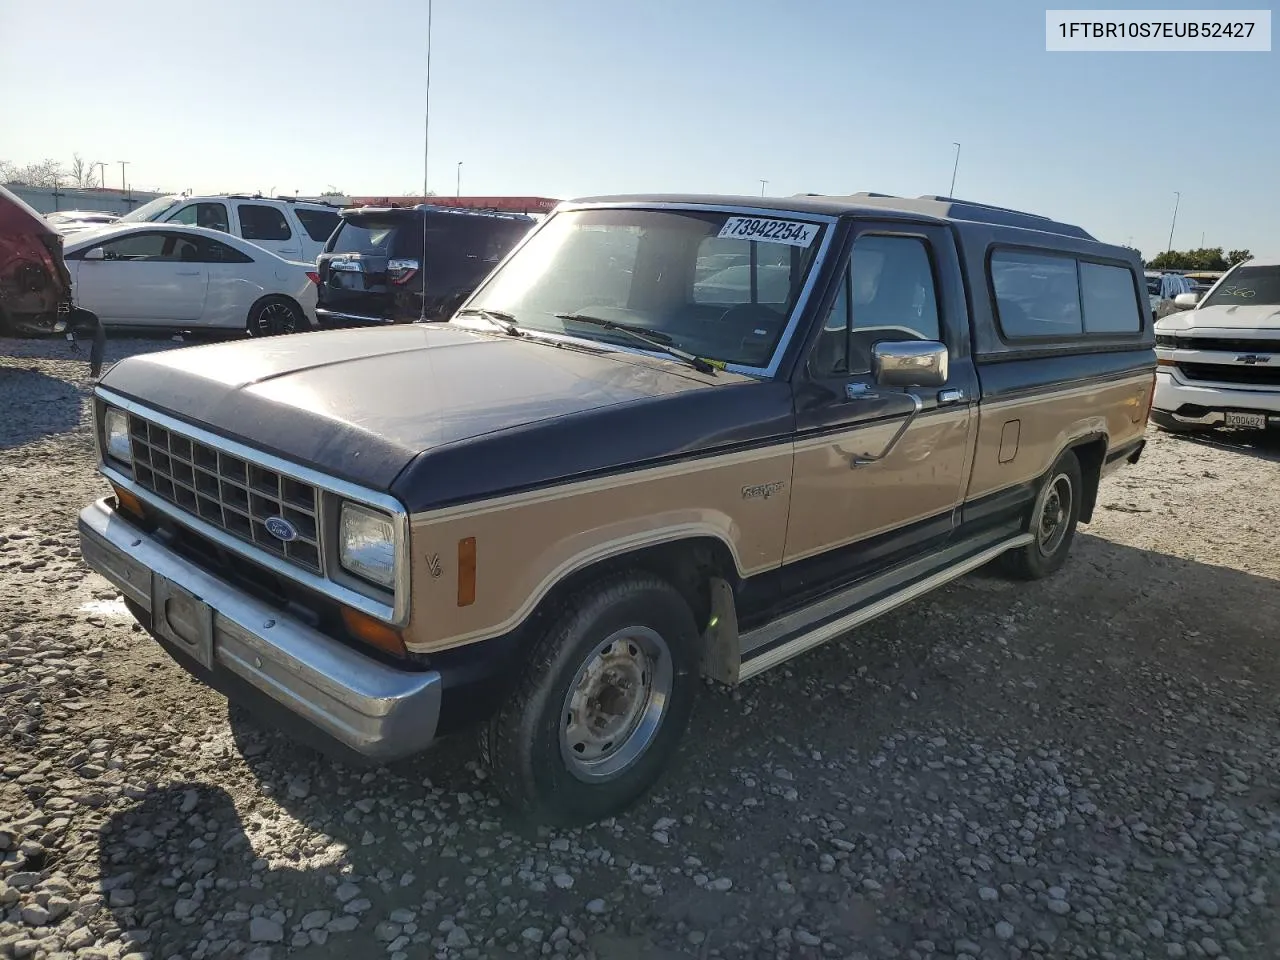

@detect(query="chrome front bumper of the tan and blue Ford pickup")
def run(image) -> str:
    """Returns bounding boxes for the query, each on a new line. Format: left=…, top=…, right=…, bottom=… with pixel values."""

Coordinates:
left=79, top=499, right=443, bottom=762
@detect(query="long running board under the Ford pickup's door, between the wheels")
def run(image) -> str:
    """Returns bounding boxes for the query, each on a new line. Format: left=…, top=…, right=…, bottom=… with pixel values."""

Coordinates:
left=737, top=534, right=1034, bottom=681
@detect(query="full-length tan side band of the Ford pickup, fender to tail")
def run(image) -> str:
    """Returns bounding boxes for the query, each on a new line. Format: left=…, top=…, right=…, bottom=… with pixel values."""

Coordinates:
left=404, top=375, right=1151, bottom=652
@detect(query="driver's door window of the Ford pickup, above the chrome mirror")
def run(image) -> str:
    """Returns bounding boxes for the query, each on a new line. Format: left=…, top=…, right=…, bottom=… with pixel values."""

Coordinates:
left=809, top=234, right=942, bottom=376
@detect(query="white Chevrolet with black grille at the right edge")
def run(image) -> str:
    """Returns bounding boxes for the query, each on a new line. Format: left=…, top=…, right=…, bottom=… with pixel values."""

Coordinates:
left=1151, top=260, right=1280, bottom=431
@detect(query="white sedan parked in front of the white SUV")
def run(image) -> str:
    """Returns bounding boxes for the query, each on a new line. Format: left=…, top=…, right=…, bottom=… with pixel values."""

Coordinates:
left=63, top=223, right=320, bottom=337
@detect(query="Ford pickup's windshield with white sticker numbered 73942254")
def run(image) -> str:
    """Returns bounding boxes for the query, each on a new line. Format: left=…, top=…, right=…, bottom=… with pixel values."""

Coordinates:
left=455, top=210, right=823, bottom=367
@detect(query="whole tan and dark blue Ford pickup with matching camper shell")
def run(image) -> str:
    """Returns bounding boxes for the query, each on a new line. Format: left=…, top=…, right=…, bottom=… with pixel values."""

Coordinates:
left=79, top=193, right=1156, bottom=823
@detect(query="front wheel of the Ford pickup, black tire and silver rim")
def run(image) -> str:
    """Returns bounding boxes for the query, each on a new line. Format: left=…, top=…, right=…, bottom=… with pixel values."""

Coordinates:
left=481, top=571, right=698, bottom=824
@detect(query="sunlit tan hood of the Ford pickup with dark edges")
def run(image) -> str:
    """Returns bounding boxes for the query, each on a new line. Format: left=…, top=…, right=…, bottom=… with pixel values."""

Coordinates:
left=94, top=324, right=737, bottom=490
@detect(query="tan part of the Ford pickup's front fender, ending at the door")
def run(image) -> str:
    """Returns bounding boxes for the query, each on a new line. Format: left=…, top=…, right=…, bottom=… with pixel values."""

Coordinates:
left=404, top=443, right=792, bottom=650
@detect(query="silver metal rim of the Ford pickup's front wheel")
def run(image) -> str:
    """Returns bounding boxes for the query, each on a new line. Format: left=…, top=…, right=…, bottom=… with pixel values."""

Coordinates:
left=561, top=627, right=672, bottom=782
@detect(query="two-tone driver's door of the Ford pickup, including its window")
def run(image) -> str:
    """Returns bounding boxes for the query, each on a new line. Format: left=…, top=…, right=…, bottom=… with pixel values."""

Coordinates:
left=783, top=221, right=977, bottom=602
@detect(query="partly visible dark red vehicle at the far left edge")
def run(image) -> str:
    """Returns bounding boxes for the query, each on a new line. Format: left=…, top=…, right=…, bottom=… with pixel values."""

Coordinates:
left=0, top=187, right=104, bottom=376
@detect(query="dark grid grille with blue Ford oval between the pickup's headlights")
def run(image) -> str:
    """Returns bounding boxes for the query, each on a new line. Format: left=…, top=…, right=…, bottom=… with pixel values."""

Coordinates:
left=129, top=413, right=321, bottom=573
